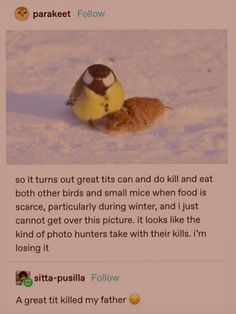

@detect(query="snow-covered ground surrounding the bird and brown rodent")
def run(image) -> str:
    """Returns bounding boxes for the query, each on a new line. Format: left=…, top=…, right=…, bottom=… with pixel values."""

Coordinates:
left=6, top=30, right=227, bottom=164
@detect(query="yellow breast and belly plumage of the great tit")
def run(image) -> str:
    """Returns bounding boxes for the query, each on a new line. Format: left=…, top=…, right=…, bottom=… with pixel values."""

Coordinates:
left=73, top=81, right=125, bottom=121
